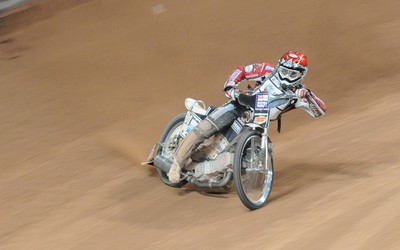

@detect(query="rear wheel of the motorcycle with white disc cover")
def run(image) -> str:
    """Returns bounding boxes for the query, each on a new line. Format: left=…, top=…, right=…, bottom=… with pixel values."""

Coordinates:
left=157, top=113, right=187, bottom=188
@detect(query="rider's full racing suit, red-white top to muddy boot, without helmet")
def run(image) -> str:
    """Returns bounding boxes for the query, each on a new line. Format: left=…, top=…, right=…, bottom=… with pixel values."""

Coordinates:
left=168, top=63, right=326, bottom=183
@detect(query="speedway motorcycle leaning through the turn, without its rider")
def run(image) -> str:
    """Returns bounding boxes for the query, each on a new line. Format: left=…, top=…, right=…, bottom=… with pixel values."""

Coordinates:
left=142, top=90, right=296, bottom=210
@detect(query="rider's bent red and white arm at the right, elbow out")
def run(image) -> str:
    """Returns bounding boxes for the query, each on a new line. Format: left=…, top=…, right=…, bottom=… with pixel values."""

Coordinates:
left=296, top=87, right=326, bottom=118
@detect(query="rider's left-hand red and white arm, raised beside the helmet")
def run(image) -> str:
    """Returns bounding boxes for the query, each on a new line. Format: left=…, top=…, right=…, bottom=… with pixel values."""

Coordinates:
left=224, top=63, right=274, bottom=99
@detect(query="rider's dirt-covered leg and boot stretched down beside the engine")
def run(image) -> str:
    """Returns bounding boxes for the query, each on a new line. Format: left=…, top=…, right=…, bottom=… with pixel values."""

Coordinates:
left=168, top=103, right=238, bottom=183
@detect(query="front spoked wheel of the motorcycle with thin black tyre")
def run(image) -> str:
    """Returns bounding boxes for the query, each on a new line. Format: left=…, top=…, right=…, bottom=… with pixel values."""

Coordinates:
left=233, top=130, right=274, bottom=210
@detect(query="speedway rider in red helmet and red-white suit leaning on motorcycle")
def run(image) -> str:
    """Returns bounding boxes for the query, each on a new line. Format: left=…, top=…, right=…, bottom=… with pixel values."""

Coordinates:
left=168, top=51, right=326, bottom=183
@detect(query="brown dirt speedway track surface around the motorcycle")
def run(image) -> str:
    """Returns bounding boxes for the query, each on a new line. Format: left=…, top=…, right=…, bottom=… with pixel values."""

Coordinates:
left=0, top=0, right=400, bottom=249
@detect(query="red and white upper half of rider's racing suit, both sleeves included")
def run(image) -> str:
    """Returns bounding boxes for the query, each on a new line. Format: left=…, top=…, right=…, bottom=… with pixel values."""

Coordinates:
left=224, top=63, right=326, bottom=120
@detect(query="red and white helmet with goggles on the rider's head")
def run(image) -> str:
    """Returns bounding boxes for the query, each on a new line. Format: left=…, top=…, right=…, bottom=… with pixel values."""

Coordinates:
left=276, top=50, right=307, bottom=89
